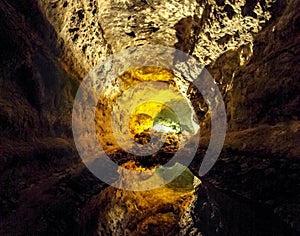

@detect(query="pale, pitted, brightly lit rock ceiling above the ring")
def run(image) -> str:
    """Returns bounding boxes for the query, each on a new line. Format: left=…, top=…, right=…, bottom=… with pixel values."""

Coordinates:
left=39, top=0, right=273, bottom=76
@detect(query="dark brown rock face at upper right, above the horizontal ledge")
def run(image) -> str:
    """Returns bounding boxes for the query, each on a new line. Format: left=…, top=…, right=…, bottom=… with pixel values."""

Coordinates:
left=228, top=1, right=300, bottom=129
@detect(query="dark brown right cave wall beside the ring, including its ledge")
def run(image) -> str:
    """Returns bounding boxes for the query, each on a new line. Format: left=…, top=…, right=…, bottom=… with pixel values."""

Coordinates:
left=202, top=1, right=299, bottom=155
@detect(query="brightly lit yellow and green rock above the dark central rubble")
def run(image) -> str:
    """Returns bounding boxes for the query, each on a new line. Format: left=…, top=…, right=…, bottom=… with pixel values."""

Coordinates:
left=95, top=67, right=199, bottom=153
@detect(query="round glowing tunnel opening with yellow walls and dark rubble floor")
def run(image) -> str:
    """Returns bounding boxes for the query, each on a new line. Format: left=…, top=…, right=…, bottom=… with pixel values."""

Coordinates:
left=95, top=66, right=199, bottom=169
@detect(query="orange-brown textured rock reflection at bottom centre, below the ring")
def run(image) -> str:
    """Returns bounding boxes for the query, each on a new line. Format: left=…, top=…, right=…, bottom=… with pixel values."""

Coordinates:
left=83, top=163, right=200, bottom=235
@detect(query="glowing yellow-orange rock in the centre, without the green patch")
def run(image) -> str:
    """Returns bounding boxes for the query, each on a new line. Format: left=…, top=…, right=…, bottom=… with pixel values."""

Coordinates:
left=95, top=66, right=193, bottom=153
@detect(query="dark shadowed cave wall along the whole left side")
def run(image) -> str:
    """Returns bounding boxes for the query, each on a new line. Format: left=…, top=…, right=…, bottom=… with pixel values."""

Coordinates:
left=0, top=0, right=105, bottom=235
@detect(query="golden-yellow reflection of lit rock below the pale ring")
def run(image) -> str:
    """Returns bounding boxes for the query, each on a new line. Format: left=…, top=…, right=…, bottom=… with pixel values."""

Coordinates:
left=100, top=162, right=201, bottom=235
